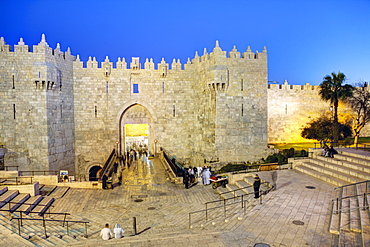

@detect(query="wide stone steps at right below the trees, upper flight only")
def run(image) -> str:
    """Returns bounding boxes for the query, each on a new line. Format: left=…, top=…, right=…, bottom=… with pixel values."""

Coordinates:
left=290, top=148, right=370, bottom=186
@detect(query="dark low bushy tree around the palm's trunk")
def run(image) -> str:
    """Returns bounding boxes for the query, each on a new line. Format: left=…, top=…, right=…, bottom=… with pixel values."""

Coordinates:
left=301, top=116, right=352, bottom=144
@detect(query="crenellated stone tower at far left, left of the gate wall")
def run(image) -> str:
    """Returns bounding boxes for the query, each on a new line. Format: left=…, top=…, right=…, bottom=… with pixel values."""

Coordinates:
left=0, top=35, right=75, bottom=174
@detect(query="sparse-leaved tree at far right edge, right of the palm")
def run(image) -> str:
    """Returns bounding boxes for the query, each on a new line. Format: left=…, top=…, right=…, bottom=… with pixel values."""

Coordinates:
left=347, top=82, right=370, bottom=145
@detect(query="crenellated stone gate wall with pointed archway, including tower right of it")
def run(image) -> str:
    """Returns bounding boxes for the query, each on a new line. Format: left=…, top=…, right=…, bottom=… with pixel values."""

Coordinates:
left=74, top=45, right=267, bottom=176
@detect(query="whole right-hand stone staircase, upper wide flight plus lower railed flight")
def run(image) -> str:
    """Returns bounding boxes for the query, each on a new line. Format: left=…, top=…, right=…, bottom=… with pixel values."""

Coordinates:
left=293, top=148, right=370, bottom=246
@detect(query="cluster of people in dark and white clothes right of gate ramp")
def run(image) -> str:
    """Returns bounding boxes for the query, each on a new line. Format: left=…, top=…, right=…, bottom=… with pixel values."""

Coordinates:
left=183, top=166, right=211, bottom=189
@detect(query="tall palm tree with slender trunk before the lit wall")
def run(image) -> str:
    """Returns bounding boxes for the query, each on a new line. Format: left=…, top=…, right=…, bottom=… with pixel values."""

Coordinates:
left=319, top=72, right=353, bottom=143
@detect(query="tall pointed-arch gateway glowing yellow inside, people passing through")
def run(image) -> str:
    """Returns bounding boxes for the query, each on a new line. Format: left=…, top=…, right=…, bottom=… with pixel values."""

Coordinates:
left=118, top=104, right=154, bottom=156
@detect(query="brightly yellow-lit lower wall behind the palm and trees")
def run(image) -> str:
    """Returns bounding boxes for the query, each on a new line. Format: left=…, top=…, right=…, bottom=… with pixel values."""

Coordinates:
left=268, top=81, right=370, bottom=143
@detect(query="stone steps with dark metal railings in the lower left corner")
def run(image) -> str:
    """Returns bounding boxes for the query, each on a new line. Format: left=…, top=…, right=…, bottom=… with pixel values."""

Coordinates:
left=0, top=186, right=93, bottom=246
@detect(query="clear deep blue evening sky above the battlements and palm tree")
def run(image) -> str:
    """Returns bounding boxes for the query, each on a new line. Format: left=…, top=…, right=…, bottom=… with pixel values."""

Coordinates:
left=0, top=0, right=370, bottom=85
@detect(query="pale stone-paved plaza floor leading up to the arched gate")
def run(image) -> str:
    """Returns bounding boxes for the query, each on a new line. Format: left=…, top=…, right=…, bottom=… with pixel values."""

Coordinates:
left=0, top=159, right=334, bottom=247
